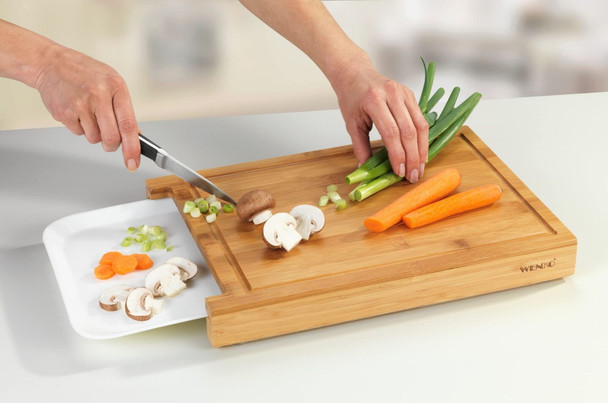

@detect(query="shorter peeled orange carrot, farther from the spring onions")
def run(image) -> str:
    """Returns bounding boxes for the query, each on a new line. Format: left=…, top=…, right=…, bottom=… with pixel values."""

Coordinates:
left=403, top=185, right=502, bottom=228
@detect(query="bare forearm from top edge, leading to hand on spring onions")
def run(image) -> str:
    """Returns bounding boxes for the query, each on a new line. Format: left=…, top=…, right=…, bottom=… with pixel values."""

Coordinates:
left=240, top=0, right=369, bottom=83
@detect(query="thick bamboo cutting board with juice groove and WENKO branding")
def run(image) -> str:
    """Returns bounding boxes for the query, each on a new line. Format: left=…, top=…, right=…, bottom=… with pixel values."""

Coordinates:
left=146, top=126, right=576, bottom=346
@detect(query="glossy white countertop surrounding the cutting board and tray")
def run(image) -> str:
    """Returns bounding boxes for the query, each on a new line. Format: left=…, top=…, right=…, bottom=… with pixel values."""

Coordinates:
left=0, top=93, right=608, bottom=402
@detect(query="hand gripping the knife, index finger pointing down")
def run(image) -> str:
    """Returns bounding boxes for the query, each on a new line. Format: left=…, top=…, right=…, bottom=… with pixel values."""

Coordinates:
left=34, top=45, right=140, bottom=171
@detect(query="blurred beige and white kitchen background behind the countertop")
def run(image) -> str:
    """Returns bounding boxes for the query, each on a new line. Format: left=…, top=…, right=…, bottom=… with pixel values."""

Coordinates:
left=0, top=0, right=608, bottom=130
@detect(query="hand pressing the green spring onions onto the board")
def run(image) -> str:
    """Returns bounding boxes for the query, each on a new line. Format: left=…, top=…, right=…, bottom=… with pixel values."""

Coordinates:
left=331, top=56, right=429, bottom=183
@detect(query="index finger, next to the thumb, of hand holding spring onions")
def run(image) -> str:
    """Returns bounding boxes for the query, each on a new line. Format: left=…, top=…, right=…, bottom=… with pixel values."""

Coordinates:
left=367, top=101, right=405, bottom=177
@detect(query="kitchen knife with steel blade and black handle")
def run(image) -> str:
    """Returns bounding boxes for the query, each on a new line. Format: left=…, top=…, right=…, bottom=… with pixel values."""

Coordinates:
left=139, top=133, right=236, bottom=206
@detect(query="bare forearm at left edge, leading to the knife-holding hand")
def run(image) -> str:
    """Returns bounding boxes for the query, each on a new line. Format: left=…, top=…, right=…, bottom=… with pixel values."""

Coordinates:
left=0, top=19, right=58, bottom=87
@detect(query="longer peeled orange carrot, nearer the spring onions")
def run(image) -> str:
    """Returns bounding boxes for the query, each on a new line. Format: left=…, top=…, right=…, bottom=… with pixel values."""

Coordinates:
left=363, top=168, right=461, bottom=232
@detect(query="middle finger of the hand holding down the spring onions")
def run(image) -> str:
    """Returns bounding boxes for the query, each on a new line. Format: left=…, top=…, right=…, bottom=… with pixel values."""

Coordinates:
left=387, top=89, right=420, bottom=183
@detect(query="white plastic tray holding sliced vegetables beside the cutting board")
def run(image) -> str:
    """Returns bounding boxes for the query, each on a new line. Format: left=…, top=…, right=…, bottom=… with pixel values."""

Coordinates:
left=42, top=199, right=220, bottom=339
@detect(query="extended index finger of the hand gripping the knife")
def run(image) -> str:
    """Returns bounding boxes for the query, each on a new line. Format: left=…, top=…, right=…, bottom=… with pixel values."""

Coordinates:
left=113, top=85, right=141, bottom=171
